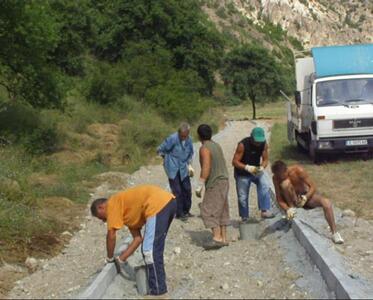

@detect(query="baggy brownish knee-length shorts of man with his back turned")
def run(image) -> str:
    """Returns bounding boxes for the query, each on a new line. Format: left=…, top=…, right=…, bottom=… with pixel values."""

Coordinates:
left=201, top=179, right=230, bottom=228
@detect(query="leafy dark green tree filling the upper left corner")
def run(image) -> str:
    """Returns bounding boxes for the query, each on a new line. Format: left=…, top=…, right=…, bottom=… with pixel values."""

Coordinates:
left=0, top=0, right=63, bottom=107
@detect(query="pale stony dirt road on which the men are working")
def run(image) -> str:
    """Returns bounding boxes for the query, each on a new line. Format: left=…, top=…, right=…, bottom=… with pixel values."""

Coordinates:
left=9, top=121, right=332, bottom=299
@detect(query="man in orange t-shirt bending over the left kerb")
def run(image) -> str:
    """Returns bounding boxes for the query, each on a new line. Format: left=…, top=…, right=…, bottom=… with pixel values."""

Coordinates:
left=91, top=185, right=176, bottom=295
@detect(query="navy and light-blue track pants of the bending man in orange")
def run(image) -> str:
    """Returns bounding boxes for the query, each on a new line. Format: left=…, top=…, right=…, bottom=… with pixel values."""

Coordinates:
left=142, top=200, right=176, bottom=295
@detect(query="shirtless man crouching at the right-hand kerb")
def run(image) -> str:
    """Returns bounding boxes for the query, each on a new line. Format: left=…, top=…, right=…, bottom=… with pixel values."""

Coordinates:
left=272, top=160, right=344, bottom=244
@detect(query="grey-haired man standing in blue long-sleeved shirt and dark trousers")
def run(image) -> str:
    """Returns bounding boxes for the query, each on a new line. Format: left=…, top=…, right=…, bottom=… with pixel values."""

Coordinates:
left=157, top=123, right=194, bottom=221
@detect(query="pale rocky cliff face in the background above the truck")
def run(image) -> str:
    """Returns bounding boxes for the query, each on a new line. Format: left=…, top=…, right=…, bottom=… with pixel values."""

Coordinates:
left=205, top=0, right=373, bottom=48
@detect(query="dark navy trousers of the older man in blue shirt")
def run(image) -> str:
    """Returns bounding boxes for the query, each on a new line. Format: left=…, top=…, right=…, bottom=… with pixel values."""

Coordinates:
left=168, top=172, right=192, bottom=217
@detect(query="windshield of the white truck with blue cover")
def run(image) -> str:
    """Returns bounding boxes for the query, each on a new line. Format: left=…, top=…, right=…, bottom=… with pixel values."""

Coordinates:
left=316, top=78, right=373, bottom=106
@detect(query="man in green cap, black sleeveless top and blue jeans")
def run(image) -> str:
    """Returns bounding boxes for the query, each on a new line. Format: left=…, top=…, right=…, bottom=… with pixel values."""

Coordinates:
left=232, top=127, right=274, bottom=222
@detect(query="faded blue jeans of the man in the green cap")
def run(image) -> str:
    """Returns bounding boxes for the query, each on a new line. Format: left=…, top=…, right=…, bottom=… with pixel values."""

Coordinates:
left=235, top=172, right=271, bottom=218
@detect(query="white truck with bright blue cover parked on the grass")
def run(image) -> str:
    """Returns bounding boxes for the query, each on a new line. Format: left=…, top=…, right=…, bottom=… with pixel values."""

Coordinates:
left=288, top=44, right=373, bottom=163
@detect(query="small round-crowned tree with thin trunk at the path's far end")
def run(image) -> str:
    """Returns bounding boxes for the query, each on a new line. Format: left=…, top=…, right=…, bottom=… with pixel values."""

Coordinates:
left=222, top=45, right=286, bottom=119
